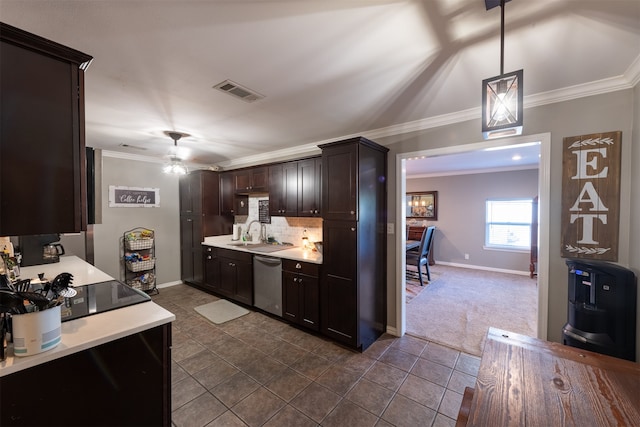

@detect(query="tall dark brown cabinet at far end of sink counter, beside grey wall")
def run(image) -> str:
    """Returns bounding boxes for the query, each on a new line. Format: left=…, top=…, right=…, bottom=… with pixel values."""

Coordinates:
left=179, top=170, right=233, bottom=286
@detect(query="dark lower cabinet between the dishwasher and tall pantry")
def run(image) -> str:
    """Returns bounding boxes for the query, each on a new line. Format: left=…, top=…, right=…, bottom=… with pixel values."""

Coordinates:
left=282, top=259, right=320, bottom=331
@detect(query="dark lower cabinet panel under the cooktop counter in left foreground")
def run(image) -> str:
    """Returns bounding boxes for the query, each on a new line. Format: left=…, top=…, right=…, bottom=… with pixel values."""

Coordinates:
left=0, top=323, right=171, bottom=426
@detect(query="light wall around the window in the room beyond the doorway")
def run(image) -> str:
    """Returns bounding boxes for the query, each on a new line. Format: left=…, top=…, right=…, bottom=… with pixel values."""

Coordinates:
left=407, top=169, right=538, bottom=274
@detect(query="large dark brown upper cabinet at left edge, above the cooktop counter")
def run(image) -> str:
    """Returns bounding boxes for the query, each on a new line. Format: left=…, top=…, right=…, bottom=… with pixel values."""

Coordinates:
left=0, top=23, right=92, bottom=236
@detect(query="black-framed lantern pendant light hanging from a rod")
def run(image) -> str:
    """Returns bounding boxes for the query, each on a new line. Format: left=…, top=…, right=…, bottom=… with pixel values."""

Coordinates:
left=482, top=0, right=523, bottom=139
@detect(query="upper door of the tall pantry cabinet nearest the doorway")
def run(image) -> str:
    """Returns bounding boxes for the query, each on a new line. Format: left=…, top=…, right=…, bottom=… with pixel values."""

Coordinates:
left=322, top=145, right=358, bottom=220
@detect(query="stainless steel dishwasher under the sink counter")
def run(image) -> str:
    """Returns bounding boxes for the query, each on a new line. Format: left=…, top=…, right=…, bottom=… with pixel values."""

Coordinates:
left=253, top=255, right=282, bottom=317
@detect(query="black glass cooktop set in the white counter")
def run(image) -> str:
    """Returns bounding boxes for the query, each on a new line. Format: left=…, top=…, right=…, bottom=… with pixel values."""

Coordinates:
left=61, top=280, right=151, bottom=322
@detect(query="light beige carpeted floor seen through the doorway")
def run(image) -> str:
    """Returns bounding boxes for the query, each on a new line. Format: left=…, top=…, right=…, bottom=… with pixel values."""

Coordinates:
left=406, top=264, right=538, bottom=356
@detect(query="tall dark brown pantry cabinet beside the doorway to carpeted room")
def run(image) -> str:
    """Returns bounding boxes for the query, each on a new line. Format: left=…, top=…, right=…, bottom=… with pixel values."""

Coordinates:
left=320, top=137, right=389, bottom=350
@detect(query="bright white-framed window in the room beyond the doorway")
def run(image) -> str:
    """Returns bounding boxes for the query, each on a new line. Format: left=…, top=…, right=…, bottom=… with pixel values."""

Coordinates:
left=485, top=199, right=533, bottom=250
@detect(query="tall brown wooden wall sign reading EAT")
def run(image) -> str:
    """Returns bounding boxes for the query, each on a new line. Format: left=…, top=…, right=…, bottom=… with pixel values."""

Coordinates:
left=561, top=131, right=622, bottom=261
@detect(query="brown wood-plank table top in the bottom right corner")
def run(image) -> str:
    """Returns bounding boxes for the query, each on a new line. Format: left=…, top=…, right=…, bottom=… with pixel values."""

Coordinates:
left=467, top=328, right=640, bottom=426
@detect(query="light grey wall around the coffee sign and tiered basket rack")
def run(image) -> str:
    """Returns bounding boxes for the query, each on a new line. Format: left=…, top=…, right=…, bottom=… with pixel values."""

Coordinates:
left=94, top=153, right=180, bottom=285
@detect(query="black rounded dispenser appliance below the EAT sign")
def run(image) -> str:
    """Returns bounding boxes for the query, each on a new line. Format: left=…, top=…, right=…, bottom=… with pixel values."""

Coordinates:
left=562, top=260, right=636, bottom=362
